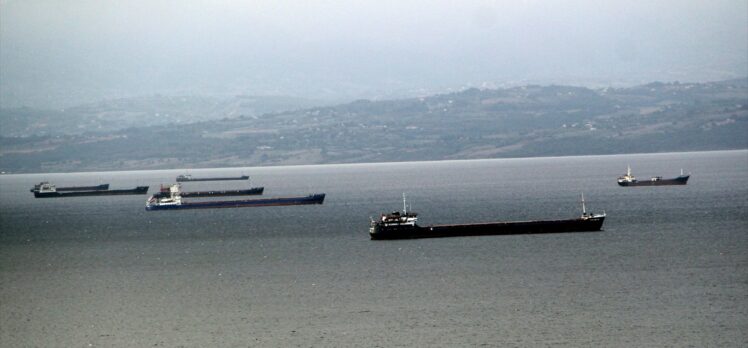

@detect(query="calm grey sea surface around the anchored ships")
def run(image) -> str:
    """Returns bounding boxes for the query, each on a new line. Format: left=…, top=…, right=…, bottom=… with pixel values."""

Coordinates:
left=0, top=151, right=748, bottom=347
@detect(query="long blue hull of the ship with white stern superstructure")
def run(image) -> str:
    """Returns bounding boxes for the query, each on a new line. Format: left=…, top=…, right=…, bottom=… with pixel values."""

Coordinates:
left=145, top=193, right=325, bottom=211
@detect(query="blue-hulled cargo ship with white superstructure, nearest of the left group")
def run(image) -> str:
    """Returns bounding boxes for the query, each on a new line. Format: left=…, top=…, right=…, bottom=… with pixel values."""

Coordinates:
left=145, top=185, right=325, bottom=210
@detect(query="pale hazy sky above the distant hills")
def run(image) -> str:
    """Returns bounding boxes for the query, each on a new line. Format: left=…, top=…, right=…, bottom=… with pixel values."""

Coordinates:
left=0, top=0, right=748, bottom=107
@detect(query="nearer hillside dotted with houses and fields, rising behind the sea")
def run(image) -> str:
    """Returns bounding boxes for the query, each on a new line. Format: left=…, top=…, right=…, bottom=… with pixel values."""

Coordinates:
left=0, top=79, right=748, bottom=172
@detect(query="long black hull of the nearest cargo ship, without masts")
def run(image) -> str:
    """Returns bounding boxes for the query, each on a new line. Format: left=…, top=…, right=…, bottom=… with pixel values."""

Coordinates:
left=369, top=216, right=605, bottom=240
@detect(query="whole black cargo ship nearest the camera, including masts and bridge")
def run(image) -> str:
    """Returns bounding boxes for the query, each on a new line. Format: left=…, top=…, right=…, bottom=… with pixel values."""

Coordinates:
left=369, top=195, right=605, bottom=240
